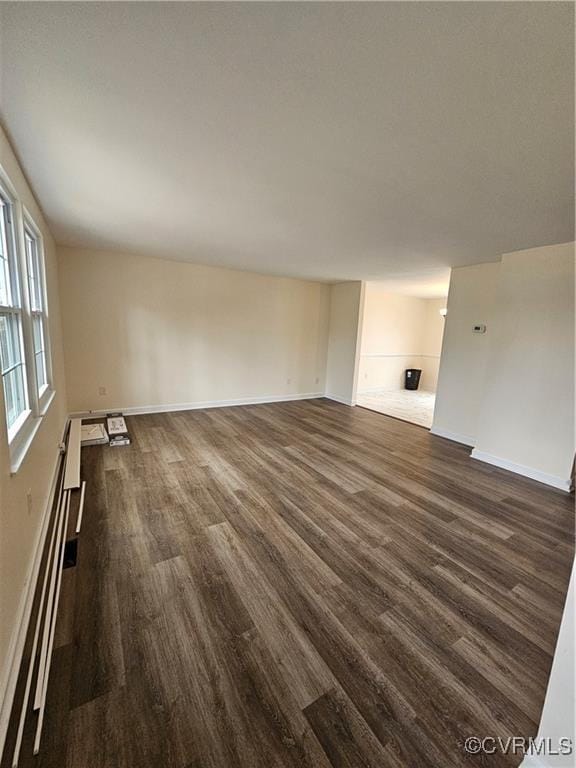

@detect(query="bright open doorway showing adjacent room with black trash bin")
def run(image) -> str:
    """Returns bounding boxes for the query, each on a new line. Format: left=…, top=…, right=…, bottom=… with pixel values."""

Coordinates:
left=356, top=276, right=448, bottom=429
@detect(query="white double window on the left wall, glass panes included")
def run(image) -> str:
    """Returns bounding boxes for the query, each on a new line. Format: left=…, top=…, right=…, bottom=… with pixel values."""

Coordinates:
left=0, top=169, right=54, bottom=471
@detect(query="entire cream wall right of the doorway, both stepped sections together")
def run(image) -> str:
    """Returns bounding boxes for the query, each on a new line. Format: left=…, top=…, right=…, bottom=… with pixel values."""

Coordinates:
left=432, top=243, right=575, bottom=488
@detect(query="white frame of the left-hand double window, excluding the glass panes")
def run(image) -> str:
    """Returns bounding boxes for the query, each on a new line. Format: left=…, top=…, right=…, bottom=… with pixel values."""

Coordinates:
left=0, top=165, right=55, bottom=474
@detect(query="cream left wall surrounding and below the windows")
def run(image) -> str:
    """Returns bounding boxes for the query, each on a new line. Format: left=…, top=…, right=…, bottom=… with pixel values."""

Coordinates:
left=0, top=128, right=67, bottom=728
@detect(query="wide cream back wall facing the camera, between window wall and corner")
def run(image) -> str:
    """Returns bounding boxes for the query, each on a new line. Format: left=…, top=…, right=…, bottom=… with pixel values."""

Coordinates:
left=58, top=248, right=330, bottom=412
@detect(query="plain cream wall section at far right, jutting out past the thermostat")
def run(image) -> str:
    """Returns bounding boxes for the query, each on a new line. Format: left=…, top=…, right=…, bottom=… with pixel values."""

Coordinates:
left=475, top=243, right=575, bottom=483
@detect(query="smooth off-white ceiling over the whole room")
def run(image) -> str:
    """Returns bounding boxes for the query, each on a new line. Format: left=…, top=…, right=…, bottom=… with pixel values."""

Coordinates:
left=0, top=2, right=574, bottom=285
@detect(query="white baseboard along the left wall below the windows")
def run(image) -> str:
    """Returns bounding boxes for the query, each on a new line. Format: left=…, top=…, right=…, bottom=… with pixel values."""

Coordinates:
left=0, top=444, right=66, bottom=755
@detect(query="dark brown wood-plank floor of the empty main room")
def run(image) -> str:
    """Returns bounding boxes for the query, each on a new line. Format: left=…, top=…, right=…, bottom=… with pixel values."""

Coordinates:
left=5, top=400, right=574, bottom=768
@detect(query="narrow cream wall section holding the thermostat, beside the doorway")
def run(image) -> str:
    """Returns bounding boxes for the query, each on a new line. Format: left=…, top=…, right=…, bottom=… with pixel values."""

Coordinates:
left=432, top=263, right=500, bottom=445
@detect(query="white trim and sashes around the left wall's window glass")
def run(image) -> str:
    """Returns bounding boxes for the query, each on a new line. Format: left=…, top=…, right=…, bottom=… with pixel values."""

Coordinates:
left=0, top=165, right=56, bottom=475
